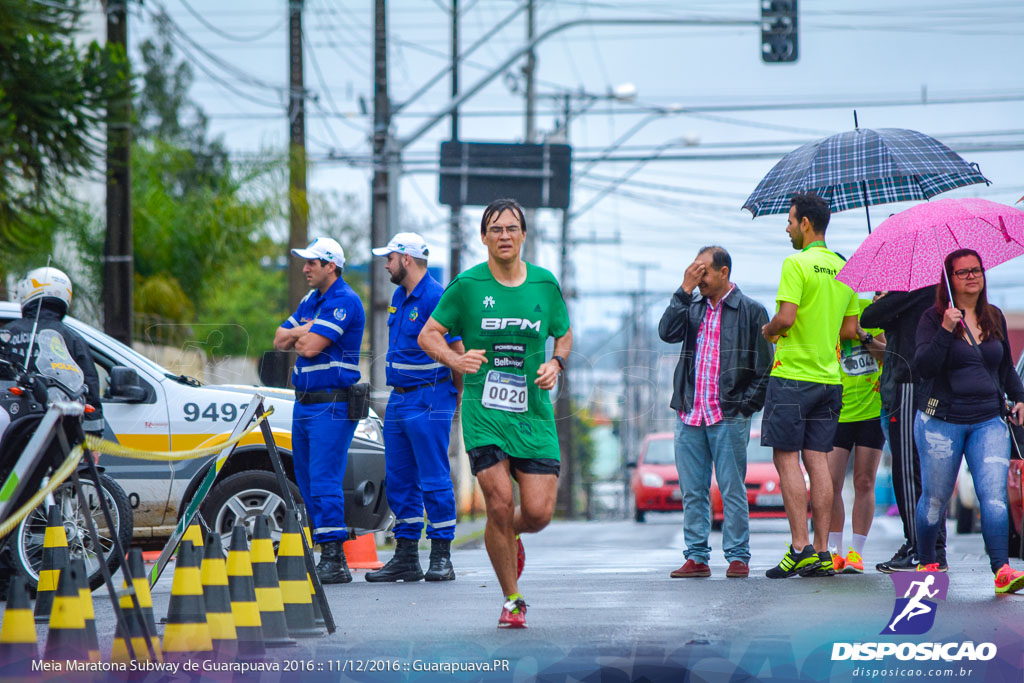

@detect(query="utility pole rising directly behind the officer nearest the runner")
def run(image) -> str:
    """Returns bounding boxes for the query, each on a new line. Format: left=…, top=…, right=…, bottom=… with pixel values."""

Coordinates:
left=370, top=0, right=389, bottom=401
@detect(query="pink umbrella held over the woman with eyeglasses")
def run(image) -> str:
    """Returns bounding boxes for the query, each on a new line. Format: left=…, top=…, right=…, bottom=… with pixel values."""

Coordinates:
left=837, top=199, right=1024, bottom=292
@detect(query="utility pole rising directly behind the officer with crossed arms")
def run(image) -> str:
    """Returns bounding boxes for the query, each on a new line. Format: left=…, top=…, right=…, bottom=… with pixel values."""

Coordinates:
left=288, top=0, right=309, bottom=310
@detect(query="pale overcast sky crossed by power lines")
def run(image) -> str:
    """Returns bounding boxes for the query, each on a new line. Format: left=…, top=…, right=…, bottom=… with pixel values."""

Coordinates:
left=88, top=0, right=1024, bottom=329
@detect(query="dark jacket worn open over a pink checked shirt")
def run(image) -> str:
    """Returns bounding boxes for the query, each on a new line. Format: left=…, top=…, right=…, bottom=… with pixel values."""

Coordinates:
left=657, top=287, right=774, bottom=418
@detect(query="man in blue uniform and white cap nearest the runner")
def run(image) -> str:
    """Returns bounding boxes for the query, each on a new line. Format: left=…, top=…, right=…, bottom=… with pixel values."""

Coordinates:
left=367, top=232, right=463, bottom=582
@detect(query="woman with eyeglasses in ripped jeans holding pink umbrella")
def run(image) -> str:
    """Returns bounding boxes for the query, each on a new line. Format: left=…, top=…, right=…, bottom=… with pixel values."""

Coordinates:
left=913, top=249, right=1024, bottom=593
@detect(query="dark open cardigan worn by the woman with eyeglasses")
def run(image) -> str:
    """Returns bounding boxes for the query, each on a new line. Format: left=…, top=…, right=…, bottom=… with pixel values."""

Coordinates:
left=913, top=306, right=1024, bottom=420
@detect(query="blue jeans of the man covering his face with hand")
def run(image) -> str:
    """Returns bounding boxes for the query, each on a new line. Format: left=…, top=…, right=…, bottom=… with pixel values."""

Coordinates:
left=676, top=417, right=751, bottom=564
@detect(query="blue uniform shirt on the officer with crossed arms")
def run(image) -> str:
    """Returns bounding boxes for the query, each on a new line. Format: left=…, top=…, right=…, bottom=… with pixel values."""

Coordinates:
left=281, top=278, right=366, bottom=391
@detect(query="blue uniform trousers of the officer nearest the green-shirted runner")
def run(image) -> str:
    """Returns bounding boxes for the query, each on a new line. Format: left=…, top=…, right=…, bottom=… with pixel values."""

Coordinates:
left=384, top=382, right=456, bottom=541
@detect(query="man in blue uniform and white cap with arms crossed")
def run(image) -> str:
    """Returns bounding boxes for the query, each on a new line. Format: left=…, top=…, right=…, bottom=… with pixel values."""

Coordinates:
left=273, top=238, right=365, bottom=584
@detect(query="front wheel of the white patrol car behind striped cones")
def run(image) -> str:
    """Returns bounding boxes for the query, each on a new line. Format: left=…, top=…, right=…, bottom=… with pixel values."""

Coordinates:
left=200, top=470, right=302, bottom=550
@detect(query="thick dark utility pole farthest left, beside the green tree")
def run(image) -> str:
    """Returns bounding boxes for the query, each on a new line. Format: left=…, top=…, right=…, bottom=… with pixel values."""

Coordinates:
left=103, top=0, right=135, bottom=346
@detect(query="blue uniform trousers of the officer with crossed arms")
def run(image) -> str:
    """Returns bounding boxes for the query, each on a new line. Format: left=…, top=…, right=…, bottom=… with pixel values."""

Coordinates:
left=292, top=401, right=358, bottom=543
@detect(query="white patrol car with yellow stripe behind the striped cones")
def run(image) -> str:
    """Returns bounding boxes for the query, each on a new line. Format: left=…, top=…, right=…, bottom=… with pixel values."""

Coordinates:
left=0, top=302, right=391, bottom=547
